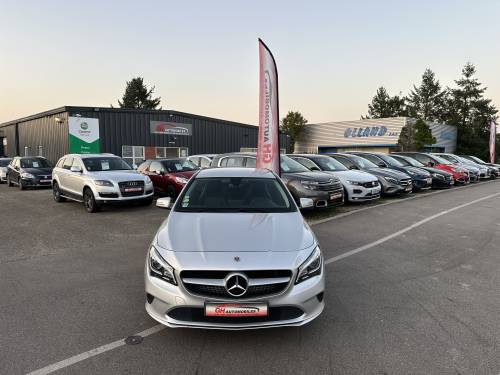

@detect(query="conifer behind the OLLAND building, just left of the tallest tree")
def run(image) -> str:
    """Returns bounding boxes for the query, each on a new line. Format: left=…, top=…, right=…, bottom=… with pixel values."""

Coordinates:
left=407, top=69, right=447, bottom=122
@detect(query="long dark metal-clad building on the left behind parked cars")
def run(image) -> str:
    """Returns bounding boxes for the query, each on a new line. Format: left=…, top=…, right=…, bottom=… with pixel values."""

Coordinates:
left=0, top=106, right=288, bottom=165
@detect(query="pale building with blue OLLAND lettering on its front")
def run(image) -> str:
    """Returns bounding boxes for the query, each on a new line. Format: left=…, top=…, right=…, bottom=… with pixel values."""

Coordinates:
left=295, top=117, right=457, bottom=153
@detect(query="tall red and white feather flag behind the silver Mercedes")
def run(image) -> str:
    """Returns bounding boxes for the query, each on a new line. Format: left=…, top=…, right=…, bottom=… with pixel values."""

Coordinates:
left=257, top=39, right=280, bottom=176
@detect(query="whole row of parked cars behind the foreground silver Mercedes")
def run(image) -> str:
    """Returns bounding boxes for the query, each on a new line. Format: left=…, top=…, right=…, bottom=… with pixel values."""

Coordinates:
left=0, top=151, right=500, bottom=212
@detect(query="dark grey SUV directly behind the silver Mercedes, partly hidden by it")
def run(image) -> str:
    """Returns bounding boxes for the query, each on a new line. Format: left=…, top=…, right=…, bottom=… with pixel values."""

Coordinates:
left=210, top=152, right=344, bottom=207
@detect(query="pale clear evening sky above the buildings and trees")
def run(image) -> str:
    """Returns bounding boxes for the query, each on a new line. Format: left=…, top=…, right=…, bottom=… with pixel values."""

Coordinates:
left=0, top=0, right=500, bottom=124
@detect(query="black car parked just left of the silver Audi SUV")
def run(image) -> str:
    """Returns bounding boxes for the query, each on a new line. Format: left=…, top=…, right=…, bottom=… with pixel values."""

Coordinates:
left=6, top=156, right=52, bottom=190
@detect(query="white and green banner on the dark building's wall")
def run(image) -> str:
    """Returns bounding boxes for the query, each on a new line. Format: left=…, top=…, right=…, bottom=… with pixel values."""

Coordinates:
left=68, top=116, right=101, bottom=154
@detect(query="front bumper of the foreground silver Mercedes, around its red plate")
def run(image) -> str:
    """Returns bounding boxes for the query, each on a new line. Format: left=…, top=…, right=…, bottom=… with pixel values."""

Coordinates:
left=145, top=263, right=325, bottom=330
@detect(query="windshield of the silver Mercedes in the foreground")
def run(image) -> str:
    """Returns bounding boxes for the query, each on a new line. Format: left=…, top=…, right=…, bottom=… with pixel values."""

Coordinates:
left=175, top=177, right=296, bottom=212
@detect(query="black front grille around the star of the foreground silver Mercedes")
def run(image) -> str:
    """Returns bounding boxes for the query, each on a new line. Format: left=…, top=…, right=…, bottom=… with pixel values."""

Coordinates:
left=180, top=270, right=292, bottom=300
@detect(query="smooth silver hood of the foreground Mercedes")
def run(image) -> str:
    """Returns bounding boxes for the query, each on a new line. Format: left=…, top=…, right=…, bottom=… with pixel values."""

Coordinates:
left=157, top=211, right=315, bottom=252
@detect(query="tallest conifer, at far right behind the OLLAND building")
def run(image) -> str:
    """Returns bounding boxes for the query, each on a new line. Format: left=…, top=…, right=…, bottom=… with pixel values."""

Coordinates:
left=446, top=63, right=498, bottom=158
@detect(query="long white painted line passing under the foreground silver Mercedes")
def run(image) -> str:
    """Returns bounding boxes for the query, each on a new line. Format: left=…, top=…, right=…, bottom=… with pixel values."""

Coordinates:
left=27, top=193, right=500, bottom=375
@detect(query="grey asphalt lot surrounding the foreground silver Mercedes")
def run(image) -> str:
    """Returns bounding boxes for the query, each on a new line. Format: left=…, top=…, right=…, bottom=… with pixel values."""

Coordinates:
left=0, top=181, right=500, bottom=374
